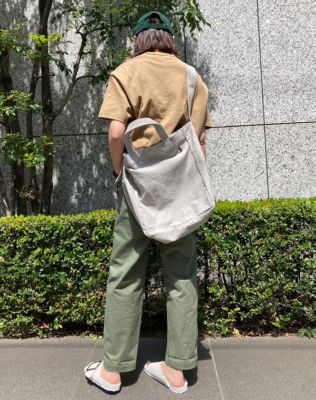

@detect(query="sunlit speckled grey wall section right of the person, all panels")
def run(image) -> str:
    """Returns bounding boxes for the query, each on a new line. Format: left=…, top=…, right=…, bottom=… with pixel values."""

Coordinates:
left=188, top=0, right=316, bottom=200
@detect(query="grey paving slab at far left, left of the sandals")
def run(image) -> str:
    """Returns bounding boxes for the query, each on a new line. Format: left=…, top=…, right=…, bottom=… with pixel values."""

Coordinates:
left=0, top=337, right=96, bottom=400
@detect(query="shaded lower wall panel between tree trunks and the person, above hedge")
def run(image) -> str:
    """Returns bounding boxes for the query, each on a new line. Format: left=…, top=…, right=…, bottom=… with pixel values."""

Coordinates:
left=52, top=134, right=116, bottom=214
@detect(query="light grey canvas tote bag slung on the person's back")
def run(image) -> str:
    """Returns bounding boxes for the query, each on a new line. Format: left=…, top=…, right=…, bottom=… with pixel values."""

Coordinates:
left=122, top=65, right=215, bottom=243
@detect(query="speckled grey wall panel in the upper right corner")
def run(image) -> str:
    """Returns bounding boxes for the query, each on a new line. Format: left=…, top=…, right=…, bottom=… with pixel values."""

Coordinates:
left=259, top=0, right=316, bottom=123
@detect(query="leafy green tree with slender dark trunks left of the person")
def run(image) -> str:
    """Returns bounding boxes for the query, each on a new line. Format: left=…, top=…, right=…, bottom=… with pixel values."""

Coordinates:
left=0, top=0, right=208, bottom=216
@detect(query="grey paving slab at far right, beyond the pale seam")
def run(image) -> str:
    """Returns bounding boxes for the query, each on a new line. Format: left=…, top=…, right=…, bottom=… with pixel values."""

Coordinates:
left=209, top=336, right=316, bottom=400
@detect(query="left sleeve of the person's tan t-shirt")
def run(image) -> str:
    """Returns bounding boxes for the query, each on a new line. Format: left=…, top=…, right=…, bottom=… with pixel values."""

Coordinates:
left=99, top=75, right=133, bottom=124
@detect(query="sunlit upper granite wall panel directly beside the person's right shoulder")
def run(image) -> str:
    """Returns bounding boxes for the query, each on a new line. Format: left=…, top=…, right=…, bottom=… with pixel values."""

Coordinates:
left=187, top=0, right=263, bottom=126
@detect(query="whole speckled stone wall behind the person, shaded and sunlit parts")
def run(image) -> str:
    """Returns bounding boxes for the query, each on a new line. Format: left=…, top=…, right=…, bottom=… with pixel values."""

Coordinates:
left=0, top=0, right=316, bottom=214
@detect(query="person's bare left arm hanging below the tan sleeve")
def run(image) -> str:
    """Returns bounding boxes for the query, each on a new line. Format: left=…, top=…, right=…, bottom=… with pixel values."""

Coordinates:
left=109, top=120, right=126, bottom=175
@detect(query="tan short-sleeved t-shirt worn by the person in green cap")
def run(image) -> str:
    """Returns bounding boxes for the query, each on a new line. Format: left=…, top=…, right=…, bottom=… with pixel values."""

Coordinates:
left=99, top=52, right=213, bottom=148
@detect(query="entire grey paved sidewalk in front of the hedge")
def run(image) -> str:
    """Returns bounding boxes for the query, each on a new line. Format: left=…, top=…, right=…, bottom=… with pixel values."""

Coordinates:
left=0, top=336, right=316, bottom=400
